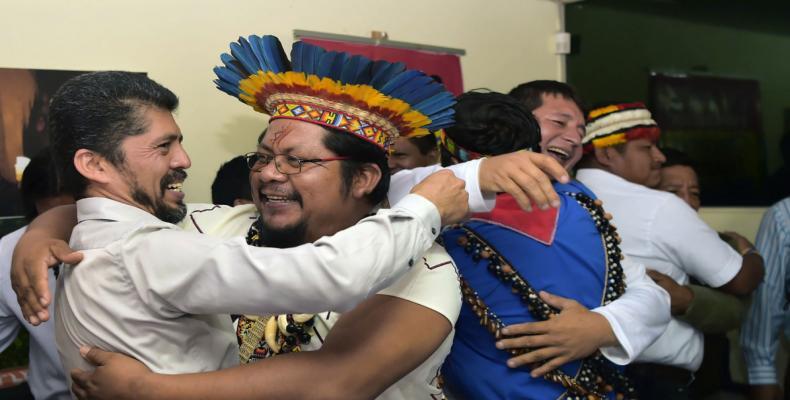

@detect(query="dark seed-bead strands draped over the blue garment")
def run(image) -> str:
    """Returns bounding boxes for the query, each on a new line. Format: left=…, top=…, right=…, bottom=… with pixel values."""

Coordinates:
left=457, top=192, right=636, bottom=400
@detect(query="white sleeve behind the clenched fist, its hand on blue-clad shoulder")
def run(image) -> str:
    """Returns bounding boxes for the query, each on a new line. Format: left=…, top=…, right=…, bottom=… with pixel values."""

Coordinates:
left=387, top=159, right=496, bottom=212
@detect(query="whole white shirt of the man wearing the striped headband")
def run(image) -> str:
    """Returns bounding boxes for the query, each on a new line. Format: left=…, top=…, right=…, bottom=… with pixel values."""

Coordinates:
left=576, top=168, right=742, bottom=371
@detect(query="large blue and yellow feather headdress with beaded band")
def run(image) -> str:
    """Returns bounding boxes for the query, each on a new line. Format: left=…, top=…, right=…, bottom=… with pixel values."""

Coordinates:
left=214, top=35, right=455, bottom=150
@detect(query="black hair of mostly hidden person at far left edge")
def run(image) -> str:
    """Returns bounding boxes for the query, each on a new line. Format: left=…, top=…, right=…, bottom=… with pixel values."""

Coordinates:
left=19, top=147, right=61, bottom=222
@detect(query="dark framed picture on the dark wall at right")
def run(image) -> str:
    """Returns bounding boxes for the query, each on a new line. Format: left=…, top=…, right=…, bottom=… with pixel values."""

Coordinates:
left=649, top=73, right=766, bottom=206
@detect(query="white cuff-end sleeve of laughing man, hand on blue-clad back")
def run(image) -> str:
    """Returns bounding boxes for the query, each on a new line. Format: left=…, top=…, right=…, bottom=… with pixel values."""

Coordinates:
left=592, top=258, right=671, bottom=365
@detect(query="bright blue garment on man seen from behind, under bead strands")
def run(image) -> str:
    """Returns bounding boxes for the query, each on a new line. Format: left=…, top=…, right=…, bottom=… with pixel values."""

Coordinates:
left=442, top=182, right=606, bottom=400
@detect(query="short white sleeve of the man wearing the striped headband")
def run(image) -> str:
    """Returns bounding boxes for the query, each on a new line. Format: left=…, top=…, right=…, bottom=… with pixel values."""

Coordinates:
left=650, top=196, right=743, bottom=288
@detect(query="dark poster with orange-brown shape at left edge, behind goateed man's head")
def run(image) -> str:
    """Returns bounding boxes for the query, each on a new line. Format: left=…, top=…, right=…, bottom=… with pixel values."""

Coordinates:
left=0, top=68, right=85, bottom=236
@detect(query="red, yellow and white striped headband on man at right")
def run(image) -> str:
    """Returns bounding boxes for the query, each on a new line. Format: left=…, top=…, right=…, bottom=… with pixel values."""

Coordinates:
left=582, top=103, right=661, bottom=154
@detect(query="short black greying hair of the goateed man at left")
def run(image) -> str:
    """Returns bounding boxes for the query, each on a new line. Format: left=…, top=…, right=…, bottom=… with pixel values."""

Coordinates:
left=49, top=71, right=178, bottom=198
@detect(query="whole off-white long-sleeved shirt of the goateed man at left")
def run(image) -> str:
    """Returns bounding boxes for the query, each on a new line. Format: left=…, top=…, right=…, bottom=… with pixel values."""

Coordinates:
left=55, top=195, right=440, bottom=390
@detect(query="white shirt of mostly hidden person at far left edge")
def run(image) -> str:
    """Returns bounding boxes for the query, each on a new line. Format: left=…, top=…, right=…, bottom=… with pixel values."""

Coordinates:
left=0, top=226, right=70, bottom=400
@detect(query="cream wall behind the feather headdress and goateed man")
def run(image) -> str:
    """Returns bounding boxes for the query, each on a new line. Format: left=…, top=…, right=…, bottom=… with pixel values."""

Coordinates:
left=0, top=0, right=560, bottom=202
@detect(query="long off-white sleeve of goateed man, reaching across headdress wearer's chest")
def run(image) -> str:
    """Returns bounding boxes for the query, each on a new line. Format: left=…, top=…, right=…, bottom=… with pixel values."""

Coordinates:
left=127, top=194, right=440, bottom=317
